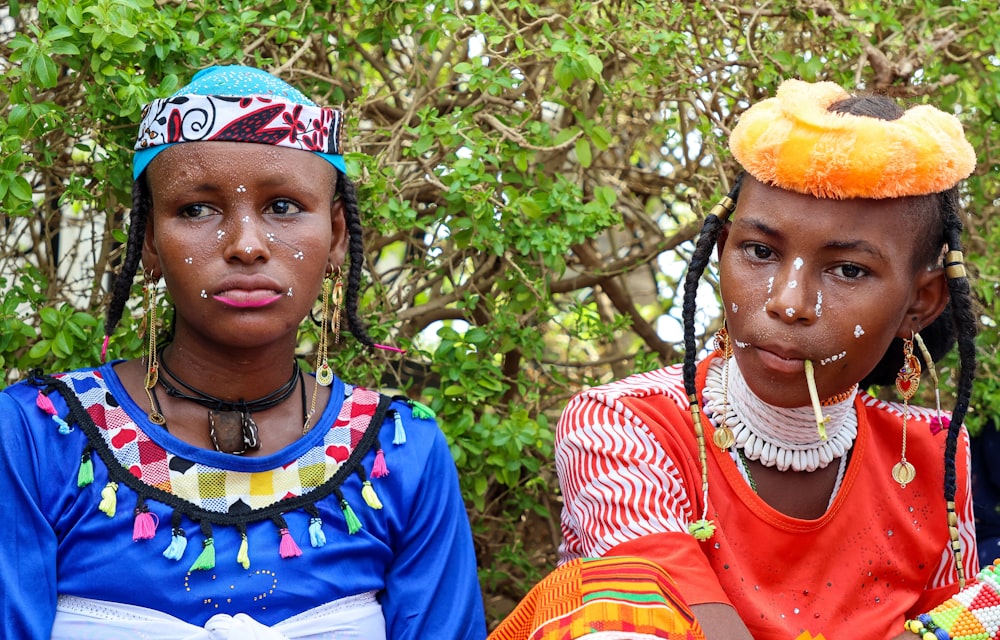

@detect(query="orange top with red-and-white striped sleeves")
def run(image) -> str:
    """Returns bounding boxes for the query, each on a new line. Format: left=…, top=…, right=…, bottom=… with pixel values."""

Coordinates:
left=556, top=362, right=978, bottom=640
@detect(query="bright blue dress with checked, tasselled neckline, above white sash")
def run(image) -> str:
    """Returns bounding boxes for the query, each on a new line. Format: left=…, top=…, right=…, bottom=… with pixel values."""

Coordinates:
left=0, top=363, right=486, bottom=640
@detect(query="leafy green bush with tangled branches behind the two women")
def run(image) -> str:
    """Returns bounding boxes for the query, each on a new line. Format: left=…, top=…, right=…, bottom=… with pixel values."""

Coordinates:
left=0, top=0, right=1000, bottom=625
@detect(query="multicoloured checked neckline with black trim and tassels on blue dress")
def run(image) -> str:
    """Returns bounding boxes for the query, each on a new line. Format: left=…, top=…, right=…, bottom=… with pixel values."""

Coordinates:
left=30, top=365, right=418, bottom=571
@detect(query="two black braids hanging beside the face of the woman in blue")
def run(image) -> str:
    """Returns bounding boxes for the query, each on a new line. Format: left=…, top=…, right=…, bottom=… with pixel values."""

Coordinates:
left=104, top=170, right=375, bottom=348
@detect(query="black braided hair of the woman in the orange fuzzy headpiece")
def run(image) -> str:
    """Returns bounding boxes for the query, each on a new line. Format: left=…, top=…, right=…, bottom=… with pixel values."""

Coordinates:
left=682, top=91, right=977, bottom=584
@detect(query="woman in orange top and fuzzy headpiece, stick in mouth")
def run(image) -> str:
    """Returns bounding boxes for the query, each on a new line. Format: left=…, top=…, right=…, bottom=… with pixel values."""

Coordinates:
left=496, top=80, right=980, bottom=640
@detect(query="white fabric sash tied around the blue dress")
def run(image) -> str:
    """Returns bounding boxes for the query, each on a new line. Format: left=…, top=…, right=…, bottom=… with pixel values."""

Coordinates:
left=52, top=591, right=385, bottom=640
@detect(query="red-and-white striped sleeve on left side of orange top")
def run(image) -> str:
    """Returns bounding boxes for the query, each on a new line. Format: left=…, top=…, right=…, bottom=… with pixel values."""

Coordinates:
left=555, top=370, right=695, bottom=562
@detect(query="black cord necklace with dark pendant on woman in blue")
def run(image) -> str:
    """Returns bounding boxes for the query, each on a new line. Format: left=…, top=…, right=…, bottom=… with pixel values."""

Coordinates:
left=157, top=356, right=305, bottom=455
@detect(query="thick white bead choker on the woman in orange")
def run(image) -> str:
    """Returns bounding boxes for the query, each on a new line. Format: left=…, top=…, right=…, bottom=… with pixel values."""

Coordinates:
left=703, top=357, right=858, bottom=471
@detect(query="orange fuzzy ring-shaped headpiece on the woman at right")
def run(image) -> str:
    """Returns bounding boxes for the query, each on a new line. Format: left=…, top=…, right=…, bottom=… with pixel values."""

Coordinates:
left=729, top=80, right=976, bottom=199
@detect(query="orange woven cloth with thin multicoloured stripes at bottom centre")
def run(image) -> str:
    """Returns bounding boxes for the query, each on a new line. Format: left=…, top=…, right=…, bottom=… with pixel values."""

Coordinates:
left=489, top=558, right=705, bottom=640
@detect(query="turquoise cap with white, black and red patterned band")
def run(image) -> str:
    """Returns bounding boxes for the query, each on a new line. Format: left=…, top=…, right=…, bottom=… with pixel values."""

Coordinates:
left=132, top=66, right=347, bottom=179
